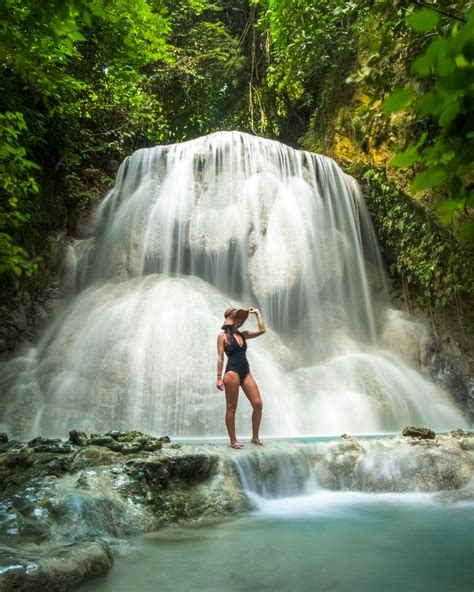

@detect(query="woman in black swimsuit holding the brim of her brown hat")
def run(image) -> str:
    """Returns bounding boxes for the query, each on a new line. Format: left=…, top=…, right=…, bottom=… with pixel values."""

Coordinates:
left=217, top=306, right=266, bottom=448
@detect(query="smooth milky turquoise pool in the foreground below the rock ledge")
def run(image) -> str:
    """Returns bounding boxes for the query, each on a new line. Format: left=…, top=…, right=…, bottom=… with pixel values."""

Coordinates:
left=81, top=491, right=474, bottom=592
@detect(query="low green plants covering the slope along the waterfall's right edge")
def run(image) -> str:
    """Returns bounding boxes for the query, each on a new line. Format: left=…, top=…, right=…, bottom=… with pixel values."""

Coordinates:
left=362, top=168, right=474, bottom=309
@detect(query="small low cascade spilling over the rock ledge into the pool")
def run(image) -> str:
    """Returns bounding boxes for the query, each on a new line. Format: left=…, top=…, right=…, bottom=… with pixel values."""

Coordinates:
left=225, top=436, right=473, bottom=515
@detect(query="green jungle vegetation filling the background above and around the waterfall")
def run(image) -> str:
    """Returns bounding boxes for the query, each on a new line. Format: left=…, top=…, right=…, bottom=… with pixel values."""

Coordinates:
left=0, top=0, right=474, bottom=312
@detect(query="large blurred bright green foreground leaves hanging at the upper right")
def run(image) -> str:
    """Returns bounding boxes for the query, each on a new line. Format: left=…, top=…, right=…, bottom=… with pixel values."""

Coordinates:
left=382, top=8, right=474, bottom=239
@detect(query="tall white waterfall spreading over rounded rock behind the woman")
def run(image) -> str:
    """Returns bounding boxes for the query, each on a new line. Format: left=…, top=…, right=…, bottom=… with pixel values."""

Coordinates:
left=0, top=132, right=466, bottom=436
